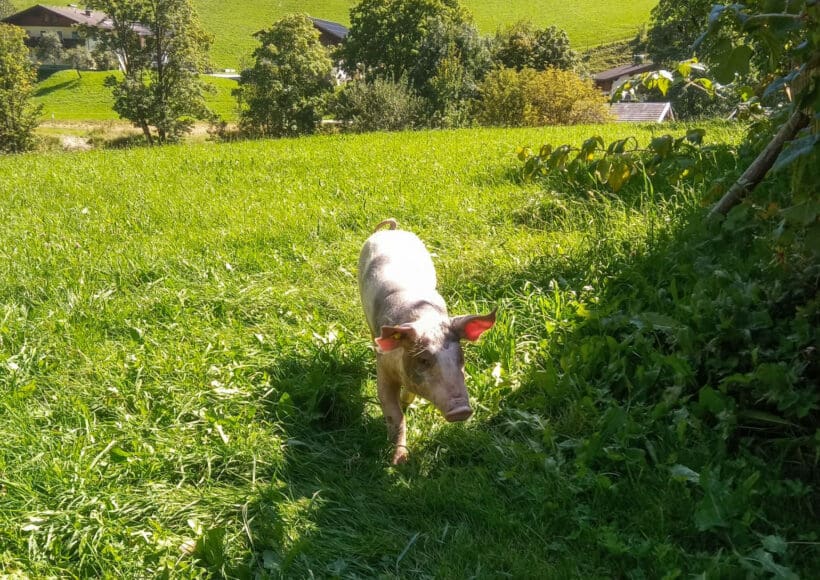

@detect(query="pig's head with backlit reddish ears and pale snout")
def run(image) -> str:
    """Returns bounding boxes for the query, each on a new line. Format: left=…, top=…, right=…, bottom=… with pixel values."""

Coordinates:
left=375, top=311, right=495, bottom=421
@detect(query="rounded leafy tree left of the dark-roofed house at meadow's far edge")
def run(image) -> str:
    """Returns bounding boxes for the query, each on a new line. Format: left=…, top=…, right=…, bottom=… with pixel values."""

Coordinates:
left=234, top=14, right=333, bottom=137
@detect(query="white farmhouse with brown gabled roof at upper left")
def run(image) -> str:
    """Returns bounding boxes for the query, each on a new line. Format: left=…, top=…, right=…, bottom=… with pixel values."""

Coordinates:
left=2, top=4, right=151, bottom=50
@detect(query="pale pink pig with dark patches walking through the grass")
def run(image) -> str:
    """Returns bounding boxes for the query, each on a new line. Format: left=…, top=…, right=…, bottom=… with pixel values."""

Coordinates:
left=359, top=218, right=496, bottom=465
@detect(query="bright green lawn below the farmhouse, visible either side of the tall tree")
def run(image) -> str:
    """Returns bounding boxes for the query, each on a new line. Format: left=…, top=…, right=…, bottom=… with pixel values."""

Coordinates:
left=32, top=70, right=236, bottom=121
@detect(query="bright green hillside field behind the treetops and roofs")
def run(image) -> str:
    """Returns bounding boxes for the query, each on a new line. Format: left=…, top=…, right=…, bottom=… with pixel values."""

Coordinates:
left=9, top=0, right=657, bottom=68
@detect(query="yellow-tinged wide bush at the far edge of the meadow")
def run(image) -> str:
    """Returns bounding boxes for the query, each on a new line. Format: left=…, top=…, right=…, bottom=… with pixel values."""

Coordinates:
left=478, top=68, right=609, bottom=127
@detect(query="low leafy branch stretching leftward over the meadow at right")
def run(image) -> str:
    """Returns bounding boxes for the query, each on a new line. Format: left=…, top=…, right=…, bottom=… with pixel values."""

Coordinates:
left=518, top=129, right=735, bottom=193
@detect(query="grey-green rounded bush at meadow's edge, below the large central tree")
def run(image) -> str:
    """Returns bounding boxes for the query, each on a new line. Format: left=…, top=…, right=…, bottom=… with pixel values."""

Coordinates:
left=333, top=79, right=424, bottom=133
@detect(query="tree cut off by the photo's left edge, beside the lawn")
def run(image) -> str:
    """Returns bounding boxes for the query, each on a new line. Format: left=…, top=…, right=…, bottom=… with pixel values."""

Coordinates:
left=0, top=24, right=42, bottom=153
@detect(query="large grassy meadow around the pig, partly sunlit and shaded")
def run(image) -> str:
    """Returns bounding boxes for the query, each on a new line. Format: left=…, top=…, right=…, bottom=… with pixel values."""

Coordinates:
left=0, top=125, right=818, bottom=578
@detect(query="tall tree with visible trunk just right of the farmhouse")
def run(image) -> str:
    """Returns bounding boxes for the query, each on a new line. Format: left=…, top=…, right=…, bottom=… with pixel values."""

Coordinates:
left=86, top=0, right=213, bottom=144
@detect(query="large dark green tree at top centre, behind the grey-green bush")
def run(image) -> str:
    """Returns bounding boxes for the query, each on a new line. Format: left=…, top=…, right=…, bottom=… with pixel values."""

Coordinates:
left=341, top=0, right=469, bottom=91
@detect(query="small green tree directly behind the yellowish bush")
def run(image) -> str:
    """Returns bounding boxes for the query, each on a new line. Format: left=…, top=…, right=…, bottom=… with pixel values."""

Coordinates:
left=495, top=21, right=578, bottom=70
